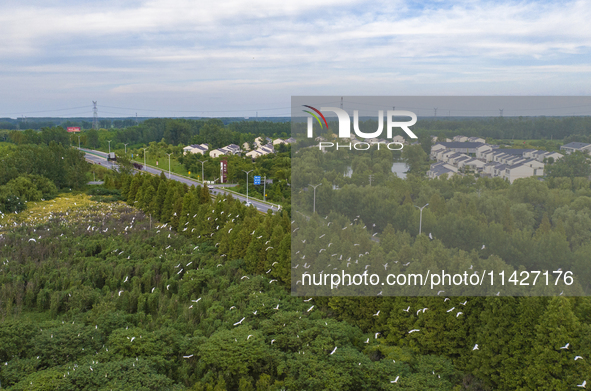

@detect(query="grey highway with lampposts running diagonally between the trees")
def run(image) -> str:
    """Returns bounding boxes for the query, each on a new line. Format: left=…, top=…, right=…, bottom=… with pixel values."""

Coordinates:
left=79, top=148, right=280, bottom=213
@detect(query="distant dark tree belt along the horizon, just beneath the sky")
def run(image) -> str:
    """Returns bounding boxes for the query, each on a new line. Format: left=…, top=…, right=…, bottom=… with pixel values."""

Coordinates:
left=6, top=116, right=591, bottom=150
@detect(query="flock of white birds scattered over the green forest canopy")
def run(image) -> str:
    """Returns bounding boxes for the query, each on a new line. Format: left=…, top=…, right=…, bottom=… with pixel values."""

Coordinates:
left=0, top=198, right=587, bottom=388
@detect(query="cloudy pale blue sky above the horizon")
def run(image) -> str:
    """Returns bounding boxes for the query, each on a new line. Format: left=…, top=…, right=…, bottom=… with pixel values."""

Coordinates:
left=0, top=0, right=591, bottom=118
